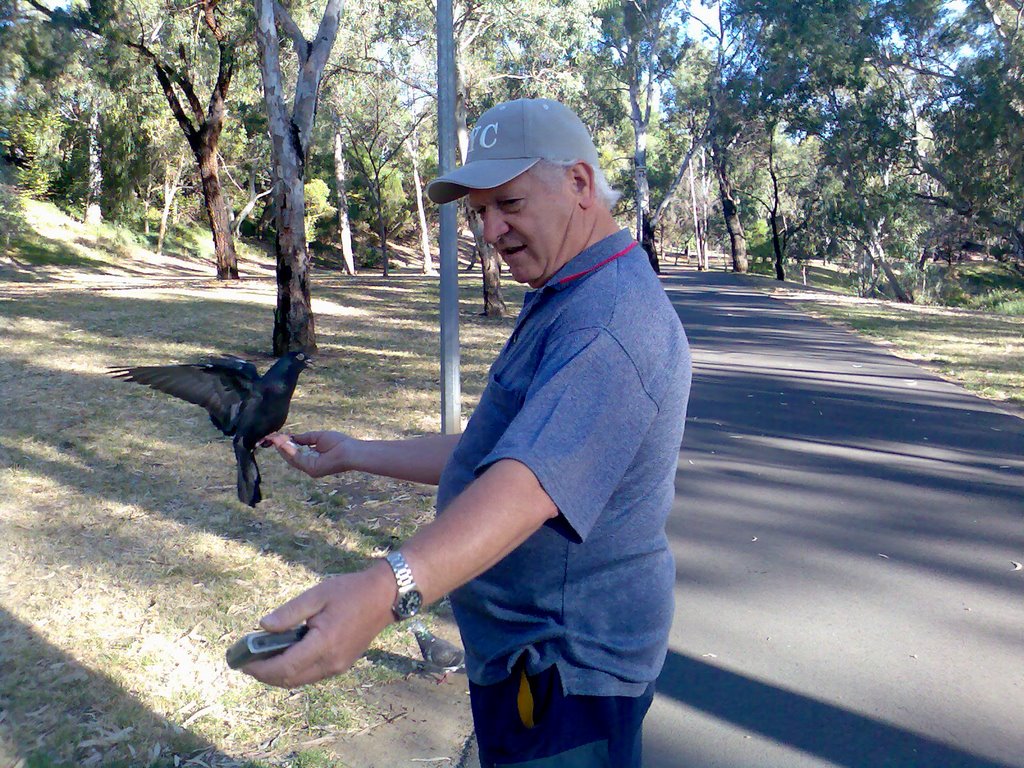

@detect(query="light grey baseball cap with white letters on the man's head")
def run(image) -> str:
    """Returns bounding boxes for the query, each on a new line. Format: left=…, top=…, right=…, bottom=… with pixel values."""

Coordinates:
left=427, top=98, right=598, bottom=203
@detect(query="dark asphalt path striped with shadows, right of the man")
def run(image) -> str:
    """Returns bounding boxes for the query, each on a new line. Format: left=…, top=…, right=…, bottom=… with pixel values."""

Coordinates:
left=644, top=272, right=1024, bottom=768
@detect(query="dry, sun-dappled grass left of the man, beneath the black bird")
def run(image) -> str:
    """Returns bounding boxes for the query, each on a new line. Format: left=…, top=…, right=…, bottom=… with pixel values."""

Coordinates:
left=0, top=201, right=521, bottom=766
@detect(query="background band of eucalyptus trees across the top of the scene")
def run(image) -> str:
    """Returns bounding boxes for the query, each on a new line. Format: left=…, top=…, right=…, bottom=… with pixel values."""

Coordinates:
left=0, top=0, right=1024, bottom=342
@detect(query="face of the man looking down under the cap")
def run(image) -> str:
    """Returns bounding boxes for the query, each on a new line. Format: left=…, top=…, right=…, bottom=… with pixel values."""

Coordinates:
left=469, top=167, right=582, bottom=289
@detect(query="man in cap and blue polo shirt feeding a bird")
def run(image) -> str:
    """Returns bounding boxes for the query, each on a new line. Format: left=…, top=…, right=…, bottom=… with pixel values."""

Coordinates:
left=246, top=99, right=690, bottom=768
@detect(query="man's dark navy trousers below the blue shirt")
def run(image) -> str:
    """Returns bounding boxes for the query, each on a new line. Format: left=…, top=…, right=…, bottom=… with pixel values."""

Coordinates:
left=469, top=665, right=654, bottom=768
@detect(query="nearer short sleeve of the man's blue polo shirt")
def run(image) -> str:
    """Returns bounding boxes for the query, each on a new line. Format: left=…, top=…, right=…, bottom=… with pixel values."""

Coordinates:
left=476, top=329, right=657, bottom=542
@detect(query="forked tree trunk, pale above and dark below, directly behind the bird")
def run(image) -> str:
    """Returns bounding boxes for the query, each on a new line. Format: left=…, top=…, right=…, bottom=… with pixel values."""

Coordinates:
left=255, top=0, right=341, bottom=356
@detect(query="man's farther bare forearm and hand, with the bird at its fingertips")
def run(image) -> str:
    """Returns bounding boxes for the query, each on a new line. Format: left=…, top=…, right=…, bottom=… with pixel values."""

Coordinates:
left=263, top=432, right=460, bottom=485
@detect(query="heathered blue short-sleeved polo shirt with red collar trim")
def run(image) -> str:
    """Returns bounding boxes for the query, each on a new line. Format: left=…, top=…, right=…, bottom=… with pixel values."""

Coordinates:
left=437, top=230, right=690, bottom=695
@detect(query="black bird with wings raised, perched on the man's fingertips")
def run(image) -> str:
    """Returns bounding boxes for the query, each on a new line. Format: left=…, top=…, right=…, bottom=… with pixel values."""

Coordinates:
left=110, top=352, right=312, bottom=507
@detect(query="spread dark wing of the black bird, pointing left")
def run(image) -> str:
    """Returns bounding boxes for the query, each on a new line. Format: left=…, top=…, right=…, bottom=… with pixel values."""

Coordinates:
left=110, top=357, right=259, bottom=434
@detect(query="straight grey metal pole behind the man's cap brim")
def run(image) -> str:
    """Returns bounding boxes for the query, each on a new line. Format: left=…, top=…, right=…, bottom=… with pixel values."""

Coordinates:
left=437, top=0, right=462, bottom=434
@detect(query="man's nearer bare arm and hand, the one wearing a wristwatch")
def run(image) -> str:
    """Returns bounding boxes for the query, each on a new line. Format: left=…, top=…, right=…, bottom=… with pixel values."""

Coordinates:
left=245, top=459, right=558, bottom=688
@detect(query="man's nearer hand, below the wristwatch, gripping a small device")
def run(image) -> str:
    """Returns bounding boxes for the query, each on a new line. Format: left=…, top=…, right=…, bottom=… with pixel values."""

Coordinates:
left=242, top=560, right=396, bottom=688
